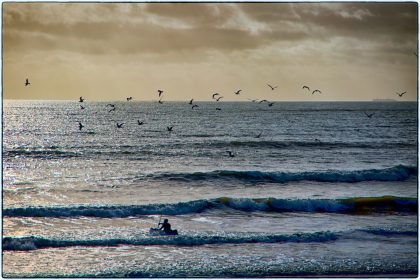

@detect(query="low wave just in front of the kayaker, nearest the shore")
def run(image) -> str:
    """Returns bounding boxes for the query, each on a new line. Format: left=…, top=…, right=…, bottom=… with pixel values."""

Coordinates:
left=3, top=231, right=337, bottom=251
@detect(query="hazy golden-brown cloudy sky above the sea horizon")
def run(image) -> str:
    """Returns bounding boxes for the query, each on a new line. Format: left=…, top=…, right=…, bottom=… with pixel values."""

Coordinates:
left=2, top=2, right=418, bottom=101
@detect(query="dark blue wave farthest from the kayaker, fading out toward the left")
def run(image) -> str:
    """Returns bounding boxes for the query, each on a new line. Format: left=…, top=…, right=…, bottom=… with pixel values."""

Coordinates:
left=150, top=165, right=417, bottom=183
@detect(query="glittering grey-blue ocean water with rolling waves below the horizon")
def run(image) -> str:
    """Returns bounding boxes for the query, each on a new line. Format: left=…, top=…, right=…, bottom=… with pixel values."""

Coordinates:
left=2, top=101, right=418, bottom=277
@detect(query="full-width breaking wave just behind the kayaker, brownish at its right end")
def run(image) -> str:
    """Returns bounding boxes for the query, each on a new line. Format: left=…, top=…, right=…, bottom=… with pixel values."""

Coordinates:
left=3, top=196, right=417, bottom=218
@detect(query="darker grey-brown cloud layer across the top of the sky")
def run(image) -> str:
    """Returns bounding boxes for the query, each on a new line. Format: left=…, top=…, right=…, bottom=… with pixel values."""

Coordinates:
left=3, top=3, right=417, bottom=54
